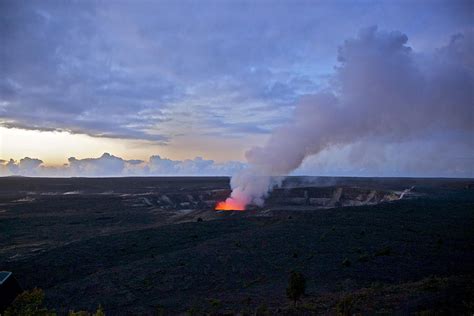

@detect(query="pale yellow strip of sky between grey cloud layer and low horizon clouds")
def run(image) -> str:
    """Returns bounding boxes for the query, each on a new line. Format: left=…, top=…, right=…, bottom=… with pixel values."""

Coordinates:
left=0, top=127, right=261, bottom=166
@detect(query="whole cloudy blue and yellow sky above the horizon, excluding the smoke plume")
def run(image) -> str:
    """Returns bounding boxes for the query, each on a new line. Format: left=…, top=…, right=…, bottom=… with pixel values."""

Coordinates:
left=0, top=0, right=474, bottom=177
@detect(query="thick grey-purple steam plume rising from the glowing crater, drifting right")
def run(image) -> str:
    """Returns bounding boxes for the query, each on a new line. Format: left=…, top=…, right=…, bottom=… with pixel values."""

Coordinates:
left=227, top=27, right=474, bottom=205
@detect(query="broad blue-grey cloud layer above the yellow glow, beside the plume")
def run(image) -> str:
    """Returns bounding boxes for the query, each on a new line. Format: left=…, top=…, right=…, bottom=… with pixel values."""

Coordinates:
left=0, top=0, right=472, bottom=142
